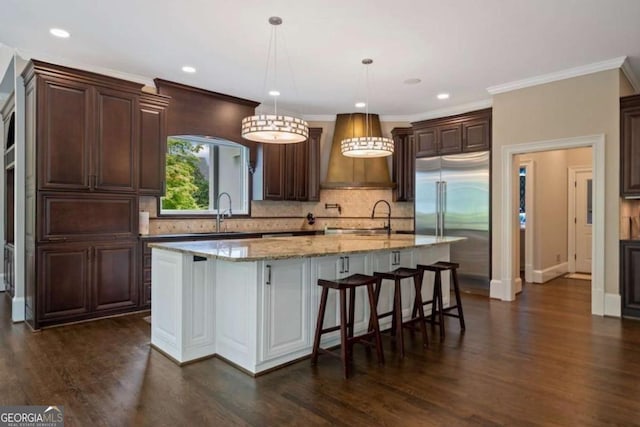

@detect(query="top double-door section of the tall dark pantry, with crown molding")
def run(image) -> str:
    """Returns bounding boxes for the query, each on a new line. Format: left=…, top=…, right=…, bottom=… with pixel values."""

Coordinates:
left=24, top=61, right=142, bottom=193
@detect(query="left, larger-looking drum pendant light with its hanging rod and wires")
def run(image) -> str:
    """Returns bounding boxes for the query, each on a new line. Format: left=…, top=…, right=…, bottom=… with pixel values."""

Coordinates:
left=242, top=16, right=309, bottom=144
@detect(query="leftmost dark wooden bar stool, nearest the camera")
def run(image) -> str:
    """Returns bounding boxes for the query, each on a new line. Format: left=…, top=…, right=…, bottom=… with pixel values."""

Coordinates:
left=311, top=274, right=384, bottom=378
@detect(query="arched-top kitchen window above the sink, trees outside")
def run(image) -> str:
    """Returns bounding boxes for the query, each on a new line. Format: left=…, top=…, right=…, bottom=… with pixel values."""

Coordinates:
left=161, top=135, right=249, bottom=215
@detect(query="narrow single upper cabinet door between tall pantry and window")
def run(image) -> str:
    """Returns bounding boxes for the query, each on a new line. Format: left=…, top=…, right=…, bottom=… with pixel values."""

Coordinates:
left=138, top=100, right=167, bottom=196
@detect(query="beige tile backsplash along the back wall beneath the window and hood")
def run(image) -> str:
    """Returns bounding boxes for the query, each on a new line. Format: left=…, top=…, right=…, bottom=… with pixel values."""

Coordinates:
left=140, top=189, right=413, bottom=234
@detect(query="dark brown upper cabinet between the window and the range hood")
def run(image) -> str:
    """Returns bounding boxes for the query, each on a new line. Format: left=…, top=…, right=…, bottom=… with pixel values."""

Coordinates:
left=262, top=128, right=322, bottom=201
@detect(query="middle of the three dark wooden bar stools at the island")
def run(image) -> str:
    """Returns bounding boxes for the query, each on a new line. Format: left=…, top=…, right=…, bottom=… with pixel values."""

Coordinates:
left=373, top=267, right=429, bottom=357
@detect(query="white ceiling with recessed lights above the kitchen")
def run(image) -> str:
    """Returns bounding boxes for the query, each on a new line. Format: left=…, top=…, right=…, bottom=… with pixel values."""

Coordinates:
left=0, top=0, right=640, bottom=119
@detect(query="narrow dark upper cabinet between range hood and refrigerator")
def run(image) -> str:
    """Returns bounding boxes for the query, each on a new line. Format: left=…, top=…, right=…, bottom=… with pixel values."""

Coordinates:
left=391, top=128, right=415, bottom=202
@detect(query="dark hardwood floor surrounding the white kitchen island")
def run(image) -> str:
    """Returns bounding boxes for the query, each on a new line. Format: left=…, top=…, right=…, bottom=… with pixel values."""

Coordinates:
left=0, top=279, right=640, bottom=426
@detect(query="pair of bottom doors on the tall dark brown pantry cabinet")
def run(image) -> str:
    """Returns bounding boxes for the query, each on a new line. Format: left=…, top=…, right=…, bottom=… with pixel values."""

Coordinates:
left=33, top=240, right=138, bottom=329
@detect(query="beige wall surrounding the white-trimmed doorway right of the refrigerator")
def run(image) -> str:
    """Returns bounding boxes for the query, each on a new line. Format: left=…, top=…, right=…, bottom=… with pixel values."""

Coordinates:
left=492, top=70, right=621, bottom=295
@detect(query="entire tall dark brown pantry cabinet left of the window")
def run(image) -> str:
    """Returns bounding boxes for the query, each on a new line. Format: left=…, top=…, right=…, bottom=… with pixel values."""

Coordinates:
left=23, top=61, right=166, bottom=329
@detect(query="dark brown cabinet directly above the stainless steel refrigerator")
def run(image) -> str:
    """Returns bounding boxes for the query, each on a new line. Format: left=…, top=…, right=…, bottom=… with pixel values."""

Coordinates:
left=412, top=108, right=491, bottom=157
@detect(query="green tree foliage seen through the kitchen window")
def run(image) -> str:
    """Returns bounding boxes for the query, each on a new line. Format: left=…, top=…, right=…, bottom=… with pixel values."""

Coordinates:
left=162, top=138, right=209, bottom=210
